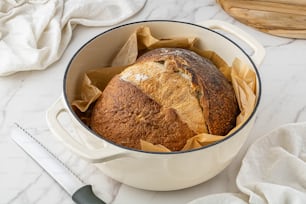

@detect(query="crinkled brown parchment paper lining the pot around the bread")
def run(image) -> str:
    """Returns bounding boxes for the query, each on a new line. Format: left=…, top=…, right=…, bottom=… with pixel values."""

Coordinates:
left=72, top=26, right=257, bottom=152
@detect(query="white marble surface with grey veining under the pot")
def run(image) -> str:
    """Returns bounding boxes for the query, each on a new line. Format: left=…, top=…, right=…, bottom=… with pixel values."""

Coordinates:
left=0, top=0, right=306, bottom=204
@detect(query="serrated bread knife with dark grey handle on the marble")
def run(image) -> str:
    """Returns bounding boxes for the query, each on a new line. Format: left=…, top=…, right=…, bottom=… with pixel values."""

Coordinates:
left=11, top=123, right=105, bottom=204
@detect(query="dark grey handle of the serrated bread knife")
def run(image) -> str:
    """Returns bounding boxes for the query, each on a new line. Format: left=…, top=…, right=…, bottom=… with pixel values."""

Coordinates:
left=72, top=185, right=106, bottom=204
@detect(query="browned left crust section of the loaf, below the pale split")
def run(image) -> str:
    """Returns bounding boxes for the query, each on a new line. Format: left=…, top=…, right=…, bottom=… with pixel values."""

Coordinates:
left=91, top=75, right=195, bottom=151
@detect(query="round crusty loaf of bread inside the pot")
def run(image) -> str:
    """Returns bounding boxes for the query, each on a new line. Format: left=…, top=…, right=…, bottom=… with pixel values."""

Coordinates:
left=90, top=48, right=239, bottom=151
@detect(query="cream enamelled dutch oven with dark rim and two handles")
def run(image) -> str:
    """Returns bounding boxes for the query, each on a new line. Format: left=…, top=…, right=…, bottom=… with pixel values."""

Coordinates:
left=47, top=20, right=265, bottom=191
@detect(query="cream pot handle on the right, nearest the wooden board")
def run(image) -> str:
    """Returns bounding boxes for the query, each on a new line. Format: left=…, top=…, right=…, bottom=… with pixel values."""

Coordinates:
left=197, top=20, right=266, bottom=66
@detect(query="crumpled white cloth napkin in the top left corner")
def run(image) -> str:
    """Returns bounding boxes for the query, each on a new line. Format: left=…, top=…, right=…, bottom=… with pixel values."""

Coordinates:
left=0, top=0, right=146, bottom=76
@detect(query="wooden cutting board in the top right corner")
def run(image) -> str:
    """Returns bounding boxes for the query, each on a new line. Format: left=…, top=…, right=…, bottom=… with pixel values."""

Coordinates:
left=216, top=0, right=306, bottom=39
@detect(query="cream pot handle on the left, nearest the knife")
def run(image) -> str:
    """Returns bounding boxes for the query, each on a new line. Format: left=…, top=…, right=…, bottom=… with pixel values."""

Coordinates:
left=46, top=97, right=127, bottom=163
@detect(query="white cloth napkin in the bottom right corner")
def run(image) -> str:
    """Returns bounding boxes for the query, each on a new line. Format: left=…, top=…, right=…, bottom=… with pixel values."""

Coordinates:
left=189, top=123, right=306, bottom=204
